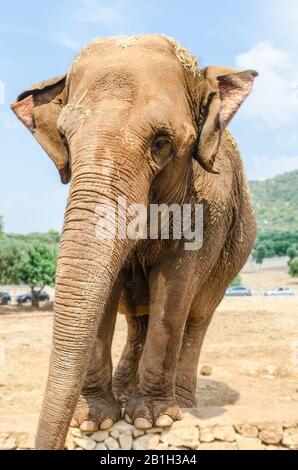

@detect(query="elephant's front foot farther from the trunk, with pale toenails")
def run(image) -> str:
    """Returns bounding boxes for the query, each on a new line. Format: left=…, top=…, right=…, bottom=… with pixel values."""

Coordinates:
left=124, top=395, right=182, bottom=429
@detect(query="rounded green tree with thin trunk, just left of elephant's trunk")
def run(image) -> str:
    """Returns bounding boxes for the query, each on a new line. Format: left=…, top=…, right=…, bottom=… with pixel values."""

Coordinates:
left=20, top=243, right=57, bottom=308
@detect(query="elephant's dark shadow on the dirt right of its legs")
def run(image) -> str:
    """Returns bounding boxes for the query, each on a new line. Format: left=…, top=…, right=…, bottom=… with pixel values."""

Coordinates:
left=189, top=378, right=240, bottom=419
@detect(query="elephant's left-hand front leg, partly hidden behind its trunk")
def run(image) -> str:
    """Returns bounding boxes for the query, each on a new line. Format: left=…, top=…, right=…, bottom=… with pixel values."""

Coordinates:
left=71, top=280, right=121, bottom=431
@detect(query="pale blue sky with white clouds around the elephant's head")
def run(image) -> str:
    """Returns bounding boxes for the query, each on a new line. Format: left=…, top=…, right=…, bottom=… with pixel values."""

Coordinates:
left=0, top=0, right=298, bottom=233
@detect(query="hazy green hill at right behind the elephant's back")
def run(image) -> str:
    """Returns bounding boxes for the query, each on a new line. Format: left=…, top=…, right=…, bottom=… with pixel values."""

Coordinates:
left=249, top=170, right=298, bottom=232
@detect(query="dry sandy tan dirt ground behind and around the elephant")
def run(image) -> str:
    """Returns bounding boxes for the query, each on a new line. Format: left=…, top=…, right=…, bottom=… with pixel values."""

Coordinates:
left=0, top=265, right=298, bottom=432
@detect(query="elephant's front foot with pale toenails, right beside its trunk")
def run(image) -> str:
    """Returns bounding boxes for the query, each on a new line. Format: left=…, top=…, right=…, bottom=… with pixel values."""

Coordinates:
left=70, top=395, right=121, bottom=432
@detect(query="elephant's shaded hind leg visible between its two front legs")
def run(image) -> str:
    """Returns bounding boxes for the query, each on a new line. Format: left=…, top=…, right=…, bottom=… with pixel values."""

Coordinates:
left=113, top=314, right=148, bottom=405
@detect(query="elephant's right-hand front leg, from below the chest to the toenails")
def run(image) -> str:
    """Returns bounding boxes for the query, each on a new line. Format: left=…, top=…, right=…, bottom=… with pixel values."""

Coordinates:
left=125, top=260, right=192, bottom=429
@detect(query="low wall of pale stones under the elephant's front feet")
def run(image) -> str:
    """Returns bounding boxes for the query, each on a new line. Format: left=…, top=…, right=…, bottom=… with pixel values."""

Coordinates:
left=0, top=413, right=298, bottom=450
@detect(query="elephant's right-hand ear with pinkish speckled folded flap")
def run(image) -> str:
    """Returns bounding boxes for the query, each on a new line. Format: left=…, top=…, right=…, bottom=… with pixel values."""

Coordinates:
left=195, top=67, right=258, bottom=174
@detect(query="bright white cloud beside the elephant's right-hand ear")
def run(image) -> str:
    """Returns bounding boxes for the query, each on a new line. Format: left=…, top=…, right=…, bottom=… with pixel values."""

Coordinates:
left=236, top=41, right=298, bottom=129
